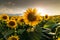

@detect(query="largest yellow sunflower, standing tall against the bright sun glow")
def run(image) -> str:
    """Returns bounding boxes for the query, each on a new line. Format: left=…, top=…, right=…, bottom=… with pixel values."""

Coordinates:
left=23, top=8, right=40, bottom=26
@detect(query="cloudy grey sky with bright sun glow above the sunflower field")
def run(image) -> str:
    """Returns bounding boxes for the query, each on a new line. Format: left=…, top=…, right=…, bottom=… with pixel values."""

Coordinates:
left=0, top=0, right=60, bottom=15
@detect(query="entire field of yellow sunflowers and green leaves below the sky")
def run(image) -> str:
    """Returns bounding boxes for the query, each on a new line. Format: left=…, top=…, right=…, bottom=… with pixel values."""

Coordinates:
left=0, top=8, right=60, bottom=40
